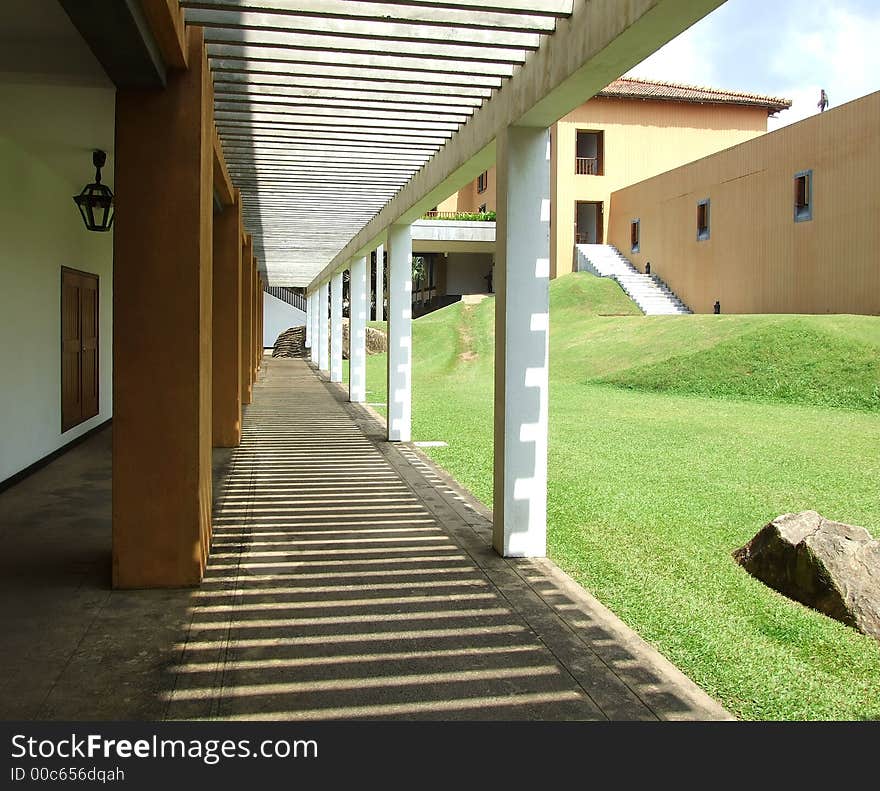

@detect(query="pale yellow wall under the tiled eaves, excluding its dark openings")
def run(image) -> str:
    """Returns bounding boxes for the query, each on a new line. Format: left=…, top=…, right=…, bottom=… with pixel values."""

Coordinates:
left=550, top=98, right=767, bottom=277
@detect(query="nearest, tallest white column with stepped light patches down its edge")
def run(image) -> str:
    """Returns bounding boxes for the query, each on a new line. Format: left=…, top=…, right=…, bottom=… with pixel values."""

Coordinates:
left=493, top=127, right=550, bottom=557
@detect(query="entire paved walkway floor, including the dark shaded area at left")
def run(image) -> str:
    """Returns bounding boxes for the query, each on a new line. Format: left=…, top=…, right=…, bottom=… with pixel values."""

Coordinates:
left=0, top=360, right=728, bottom=720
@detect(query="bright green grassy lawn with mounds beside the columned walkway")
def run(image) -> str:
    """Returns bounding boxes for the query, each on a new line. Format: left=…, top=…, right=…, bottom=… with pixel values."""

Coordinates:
left=350, top=274, right=880, bottom=719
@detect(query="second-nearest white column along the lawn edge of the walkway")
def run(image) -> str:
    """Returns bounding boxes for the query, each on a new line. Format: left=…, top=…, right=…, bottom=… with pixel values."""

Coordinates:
left=380, top=225, right=412, bottom=442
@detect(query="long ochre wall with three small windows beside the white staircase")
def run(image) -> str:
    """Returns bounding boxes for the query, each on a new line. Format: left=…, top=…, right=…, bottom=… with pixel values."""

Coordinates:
left=609, top=92, right=880, bottom=314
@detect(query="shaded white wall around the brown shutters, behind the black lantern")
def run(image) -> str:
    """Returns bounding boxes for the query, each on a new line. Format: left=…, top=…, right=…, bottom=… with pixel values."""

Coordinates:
left=0, top=85, right=114, bottom=481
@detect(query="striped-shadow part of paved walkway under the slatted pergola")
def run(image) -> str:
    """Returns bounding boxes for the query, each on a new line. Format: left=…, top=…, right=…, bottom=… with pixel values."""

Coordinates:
left=162, top=360, right=722, bottom=720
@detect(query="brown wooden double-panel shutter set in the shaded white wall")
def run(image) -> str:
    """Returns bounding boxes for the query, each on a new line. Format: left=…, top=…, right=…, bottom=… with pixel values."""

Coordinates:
left=61, top=268, right=98, bottom=432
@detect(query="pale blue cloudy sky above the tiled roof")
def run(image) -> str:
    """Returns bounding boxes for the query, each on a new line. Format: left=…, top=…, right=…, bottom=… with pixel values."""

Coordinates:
left=628, top=0, right=880, bottom=129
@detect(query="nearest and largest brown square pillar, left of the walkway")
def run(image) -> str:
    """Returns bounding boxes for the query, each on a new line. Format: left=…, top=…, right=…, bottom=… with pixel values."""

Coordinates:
left=112, top=27, right=213, bottom=588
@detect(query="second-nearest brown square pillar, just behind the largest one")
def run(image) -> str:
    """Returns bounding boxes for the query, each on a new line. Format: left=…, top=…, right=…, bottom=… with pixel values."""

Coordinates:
left=211, top=190, right=242, bottom=448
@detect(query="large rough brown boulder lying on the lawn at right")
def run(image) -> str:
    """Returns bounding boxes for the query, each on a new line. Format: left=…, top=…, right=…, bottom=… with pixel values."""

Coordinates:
left=733, top=511, right=880, bottom=640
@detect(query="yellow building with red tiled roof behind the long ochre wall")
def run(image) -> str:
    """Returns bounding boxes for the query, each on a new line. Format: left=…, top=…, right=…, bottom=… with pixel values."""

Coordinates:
left=437, top=79, right=791, bottom=277
